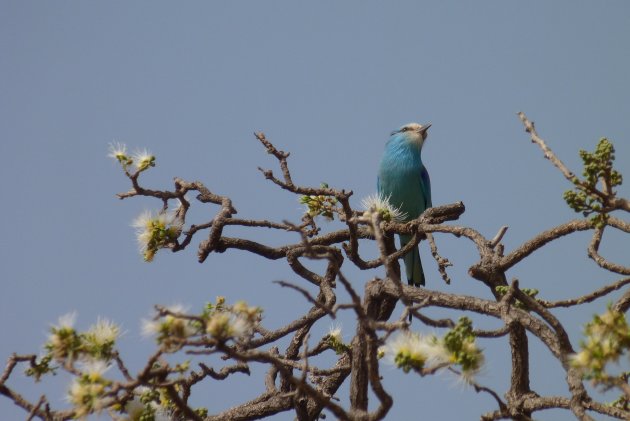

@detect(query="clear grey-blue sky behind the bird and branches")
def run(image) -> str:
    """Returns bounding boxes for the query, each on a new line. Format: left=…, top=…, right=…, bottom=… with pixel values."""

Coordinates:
left=0, top=0, right=630, bottom=420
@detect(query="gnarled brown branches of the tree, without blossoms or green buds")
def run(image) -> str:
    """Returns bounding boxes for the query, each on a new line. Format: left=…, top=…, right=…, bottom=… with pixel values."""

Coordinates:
left=0, top=125, right=630, bottom=421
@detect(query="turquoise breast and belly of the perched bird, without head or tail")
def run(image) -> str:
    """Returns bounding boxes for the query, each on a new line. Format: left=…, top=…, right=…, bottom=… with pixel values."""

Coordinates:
left=377, top=135, right=431, bottom=220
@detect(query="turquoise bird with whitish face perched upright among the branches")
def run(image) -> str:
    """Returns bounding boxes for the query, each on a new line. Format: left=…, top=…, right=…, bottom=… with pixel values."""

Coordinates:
left=376, top=123, right=432, bottom=286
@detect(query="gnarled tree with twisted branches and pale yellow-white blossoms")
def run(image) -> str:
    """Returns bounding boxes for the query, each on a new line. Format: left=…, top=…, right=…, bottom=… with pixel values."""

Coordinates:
left=0, top=113, right=630, bottom=420
